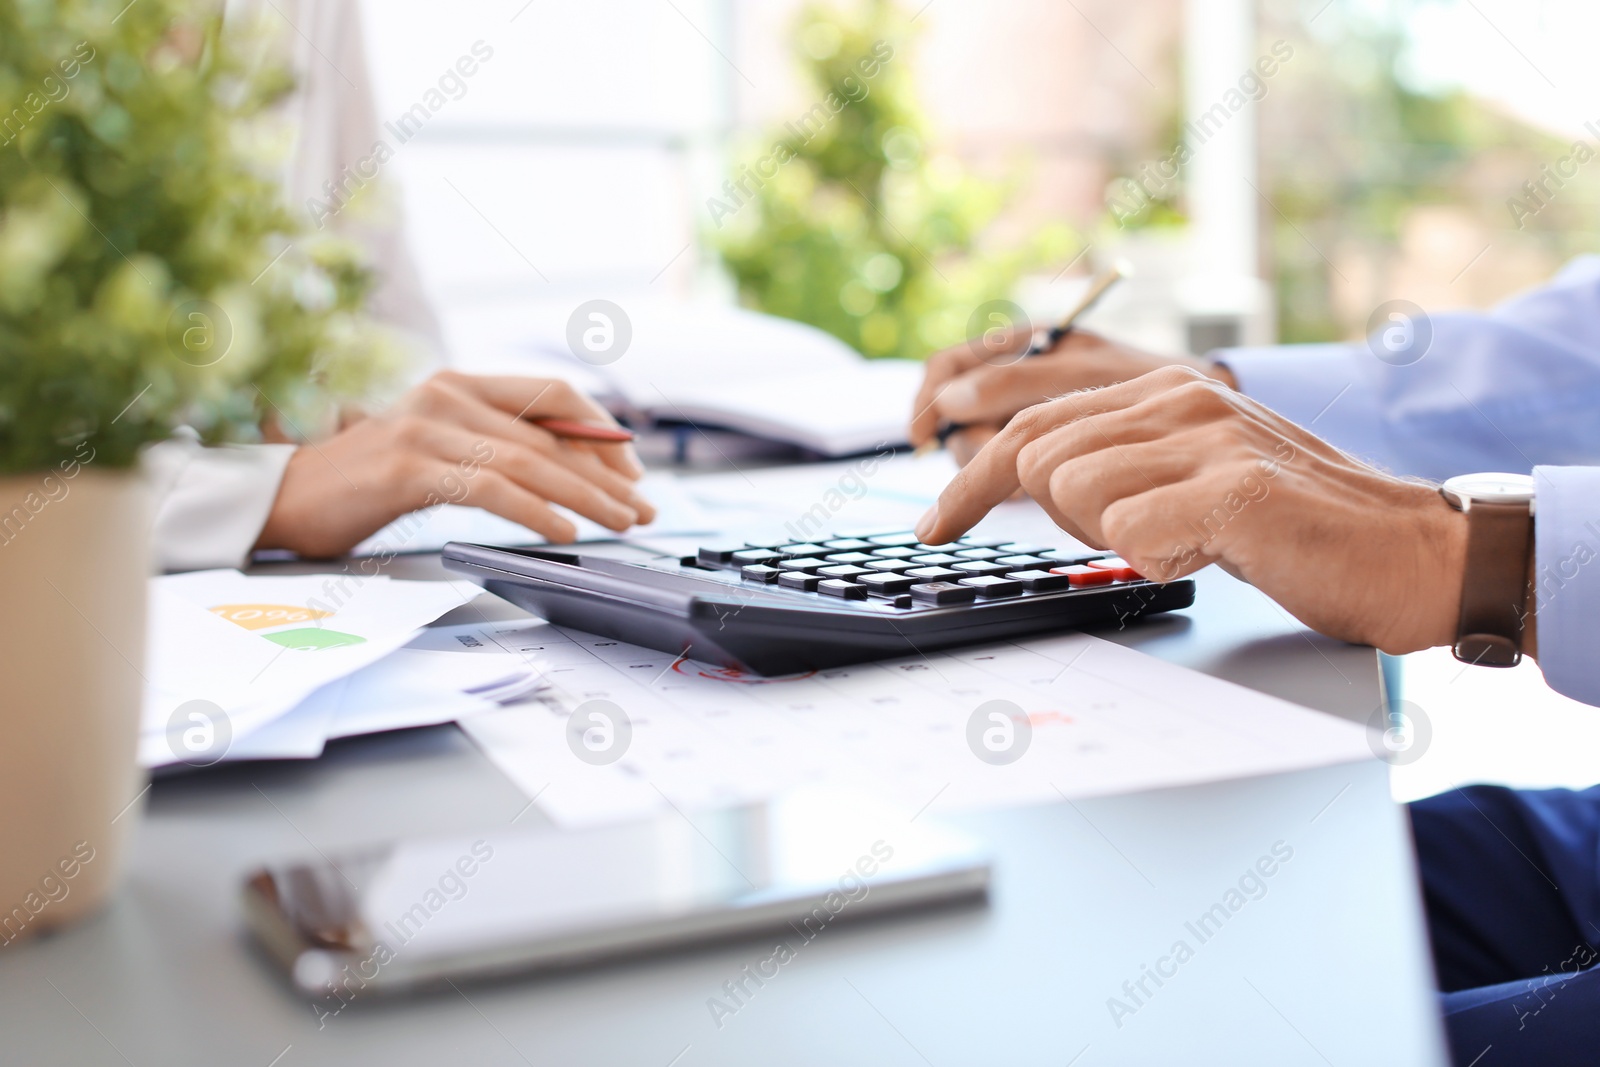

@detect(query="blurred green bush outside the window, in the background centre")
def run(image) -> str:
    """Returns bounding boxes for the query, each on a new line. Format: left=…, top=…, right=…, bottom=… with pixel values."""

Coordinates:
left=706, top=0, right=1075, bottom=358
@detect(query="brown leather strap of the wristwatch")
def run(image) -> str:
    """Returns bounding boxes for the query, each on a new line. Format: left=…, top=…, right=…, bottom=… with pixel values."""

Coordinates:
left=1456, top=501, right=1533, bottom=667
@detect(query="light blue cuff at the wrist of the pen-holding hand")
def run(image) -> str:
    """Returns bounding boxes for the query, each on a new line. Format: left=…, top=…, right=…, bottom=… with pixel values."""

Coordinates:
left=1211, top=344, right=1403, bottom=470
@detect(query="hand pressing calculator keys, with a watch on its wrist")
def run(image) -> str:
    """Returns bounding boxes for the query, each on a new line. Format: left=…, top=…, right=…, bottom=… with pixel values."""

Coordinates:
left=917, top=368, right=1467, bottom=654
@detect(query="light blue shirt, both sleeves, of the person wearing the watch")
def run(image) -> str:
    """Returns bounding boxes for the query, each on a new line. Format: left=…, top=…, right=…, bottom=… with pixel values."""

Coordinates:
left=1213, top=256, right=1600, bottom=705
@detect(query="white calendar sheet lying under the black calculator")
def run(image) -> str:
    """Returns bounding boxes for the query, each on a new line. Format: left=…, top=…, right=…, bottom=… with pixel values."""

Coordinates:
left=462, top=622, right=1373, bottom=825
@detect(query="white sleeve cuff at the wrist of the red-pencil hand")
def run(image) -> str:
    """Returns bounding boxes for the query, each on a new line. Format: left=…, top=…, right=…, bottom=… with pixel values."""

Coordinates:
left=144, top=435, right=294, bottom=571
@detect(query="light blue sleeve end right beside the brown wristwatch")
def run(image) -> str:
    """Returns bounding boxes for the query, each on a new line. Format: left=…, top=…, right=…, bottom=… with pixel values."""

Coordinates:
left=1533, top=467, right=1600, bottom=707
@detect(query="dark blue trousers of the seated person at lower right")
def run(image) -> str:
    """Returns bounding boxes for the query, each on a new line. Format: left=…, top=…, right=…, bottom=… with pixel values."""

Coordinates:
left=1410, top=785, right=1600, bottom=1067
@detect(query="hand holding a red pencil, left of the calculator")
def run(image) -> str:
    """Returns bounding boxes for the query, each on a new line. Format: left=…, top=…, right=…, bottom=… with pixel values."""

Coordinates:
left=256, top=371, right=656, bottom=557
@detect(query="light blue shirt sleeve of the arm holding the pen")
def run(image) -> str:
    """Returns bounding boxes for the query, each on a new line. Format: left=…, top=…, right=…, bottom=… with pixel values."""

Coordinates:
left=1213, top=256, right=1600, bottom=480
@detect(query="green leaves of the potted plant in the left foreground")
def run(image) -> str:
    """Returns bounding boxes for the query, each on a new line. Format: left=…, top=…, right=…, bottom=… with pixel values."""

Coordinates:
left=0, top=0, right=397, bottom=472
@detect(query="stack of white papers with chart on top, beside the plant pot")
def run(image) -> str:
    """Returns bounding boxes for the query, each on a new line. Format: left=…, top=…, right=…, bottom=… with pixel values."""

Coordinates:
left=139, top=571, right=504, bottom=768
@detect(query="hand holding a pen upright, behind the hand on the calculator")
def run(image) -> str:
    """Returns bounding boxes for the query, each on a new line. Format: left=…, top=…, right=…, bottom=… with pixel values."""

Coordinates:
left=910, top=330, right=1235, bottom=464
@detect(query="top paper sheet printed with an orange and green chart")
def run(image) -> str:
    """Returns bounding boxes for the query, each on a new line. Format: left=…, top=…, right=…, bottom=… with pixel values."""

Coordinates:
left=139, top=571, right=480, bottom=766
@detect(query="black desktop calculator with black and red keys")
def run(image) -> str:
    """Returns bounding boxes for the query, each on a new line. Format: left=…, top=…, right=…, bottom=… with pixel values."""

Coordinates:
left=443, top=531, right=1195, bottom=675
